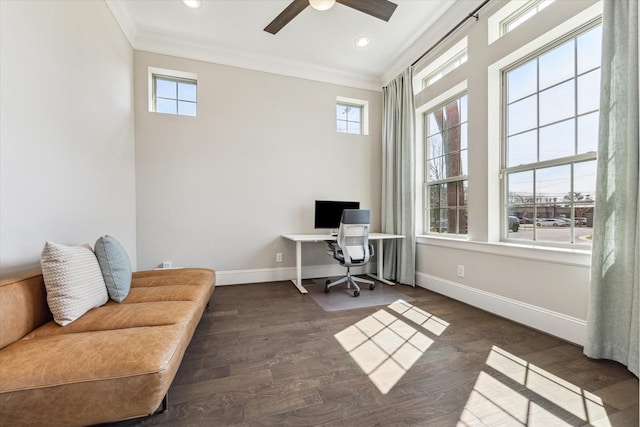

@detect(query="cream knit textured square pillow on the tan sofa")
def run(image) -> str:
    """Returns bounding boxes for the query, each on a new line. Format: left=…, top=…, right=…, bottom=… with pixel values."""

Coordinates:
left=40, top=242, right=109, bottom=326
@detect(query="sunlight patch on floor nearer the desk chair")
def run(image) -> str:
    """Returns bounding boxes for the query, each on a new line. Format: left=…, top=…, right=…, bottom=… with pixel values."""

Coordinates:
left=335, top=300, right=442, bottom=394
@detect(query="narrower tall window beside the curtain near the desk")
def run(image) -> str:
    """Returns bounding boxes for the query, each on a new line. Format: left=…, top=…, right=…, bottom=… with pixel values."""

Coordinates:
left=424, top=95, right=468, bottom=234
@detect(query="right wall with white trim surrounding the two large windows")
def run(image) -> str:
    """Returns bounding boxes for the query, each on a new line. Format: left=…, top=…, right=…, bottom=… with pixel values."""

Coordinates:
left=416, top=0, right=596, bottom=343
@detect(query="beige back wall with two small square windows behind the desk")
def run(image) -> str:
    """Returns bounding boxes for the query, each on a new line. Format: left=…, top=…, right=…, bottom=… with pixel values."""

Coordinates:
left=135, top=51, right=382, bottom=283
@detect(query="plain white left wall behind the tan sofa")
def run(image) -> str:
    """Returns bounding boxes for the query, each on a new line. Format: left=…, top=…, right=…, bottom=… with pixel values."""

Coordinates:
left=0, top=0, right=136, bottom=276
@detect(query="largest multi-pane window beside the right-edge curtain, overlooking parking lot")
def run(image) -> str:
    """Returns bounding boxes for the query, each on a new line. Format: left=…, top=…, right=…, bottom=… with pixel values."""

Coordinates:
left=501, top=24, right=601, bottom=245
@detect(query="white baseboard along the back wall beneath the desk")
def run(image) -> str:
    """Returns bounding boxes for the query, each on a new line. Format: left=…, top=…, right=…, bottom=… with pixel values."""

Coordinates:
left=216, top=263, right=376, bottom=286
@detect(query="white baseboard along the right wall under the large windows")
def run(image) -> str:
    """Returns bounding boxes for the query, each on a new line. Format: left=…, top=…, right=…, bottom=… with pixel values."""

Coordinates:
left=416, top=272, right=587, bottom=346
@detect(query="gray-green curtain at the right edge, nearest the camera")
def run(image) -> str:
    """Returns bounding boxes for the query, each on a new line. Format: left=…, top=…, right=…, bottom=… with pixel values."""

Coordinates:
left=584, top=0, right=640, bottom=376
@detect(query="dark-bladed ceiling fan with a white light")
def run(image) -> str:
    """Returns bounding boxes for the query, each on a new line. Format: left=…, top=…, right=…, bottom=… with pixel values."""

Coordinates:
left=264, top=0, right=398, bottom=34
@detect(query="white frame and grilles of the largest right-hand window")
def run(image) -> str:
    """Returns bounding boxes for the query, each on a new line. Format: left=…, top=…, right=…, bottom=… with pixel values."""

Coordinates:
left=499, top=19, right=602, bottom=247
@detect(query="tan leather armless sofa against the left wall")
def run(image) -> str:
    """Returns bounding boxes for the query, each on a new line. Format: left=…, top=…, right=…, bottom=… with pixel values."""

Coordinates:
left=0, top=269, right=215, bottom=426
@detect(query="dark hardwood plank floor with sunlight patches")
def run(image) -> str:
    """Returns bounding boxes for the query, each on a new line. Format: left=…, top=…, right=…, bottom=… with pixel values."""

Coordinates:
left=116, top=281, right=638, bottom=427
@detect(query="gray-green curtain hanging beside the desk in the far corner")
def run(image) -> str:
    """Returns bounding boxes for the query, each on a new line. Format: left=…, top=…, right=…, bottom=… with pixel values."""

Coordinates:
left=382, top=67, right=416, bottom=286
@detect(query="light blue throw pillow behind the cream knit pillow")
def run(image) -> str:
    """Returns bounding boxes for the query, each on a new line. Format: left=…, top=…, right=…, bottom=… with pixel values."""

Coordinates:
left=94, top=236, right=131, bottom=302
